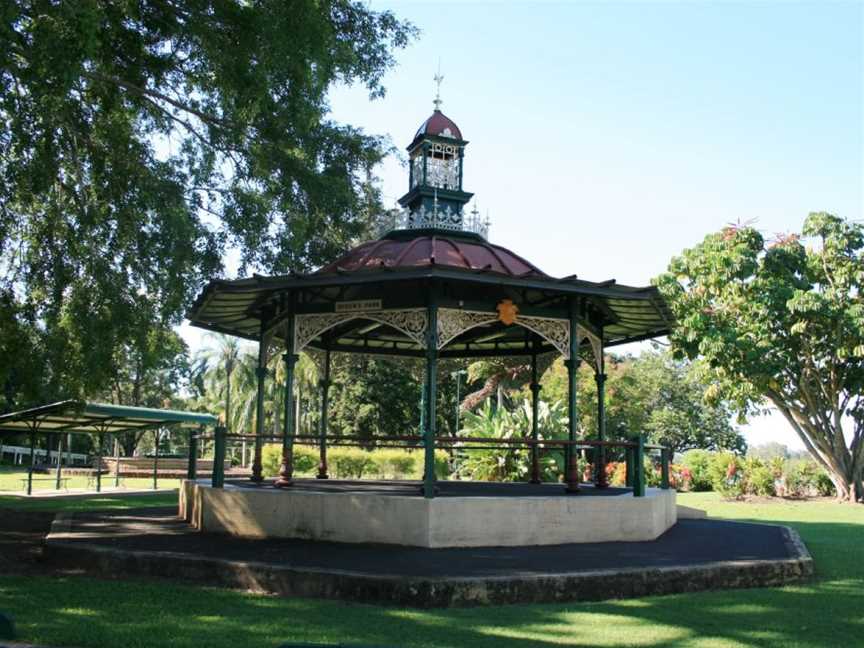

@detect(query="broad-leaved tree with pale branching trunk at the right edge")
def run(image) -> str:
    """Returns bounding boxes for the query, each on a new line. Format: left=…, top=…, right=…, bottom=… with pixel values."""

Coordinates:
left=657, top=213, right=864, bottom=501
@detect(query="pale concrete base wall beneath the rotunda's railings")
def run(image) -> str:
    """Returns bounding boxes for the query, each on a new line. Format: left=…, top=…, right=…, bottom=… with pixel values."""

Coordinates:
left=179, top=481, right=677, bottom=548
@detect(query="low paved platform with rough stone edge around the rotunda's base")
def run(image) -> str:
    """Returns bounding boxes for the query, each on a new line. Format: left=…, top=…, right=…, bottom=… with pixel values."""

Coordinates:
left=46, top=508, right=813, bottom=607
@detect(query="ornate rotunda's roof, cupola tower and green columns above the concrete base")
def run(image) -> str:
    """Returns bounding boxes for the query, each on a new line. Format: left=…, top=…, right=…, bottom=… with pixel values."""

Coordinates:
left=189, top=99, right=672, bottom=498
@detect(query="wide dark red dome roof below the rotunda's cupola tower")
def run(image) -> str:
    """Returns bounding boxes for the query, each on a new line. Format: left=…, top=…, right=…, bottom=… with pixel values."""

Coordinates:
left=315, top=230, right=547, bottom=277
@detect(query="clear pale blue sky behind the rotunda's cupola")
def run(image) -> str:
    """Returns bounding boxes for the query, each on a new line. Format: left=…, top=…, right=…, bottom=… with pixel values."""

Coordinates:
left=184, top=2, right=864, bottom=447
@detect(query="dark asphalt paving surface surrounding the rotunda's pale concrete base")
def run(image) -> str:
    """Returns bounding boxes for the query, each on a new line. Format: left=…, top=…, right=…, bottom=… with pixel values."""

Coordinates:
left=55, top=508, right=793, bottom=577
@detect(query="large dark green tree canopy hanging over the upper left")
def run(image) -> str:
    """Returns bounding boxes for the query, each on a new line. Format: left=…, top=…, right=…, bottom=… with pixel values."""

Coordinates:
left=0, top=0, right=414, bottom=410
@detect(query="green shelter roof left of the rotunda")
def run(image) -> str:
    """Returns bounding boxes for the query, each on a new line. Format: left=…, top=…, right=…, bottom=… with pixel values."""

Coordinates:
left=0, top=400, right=218, bottom=434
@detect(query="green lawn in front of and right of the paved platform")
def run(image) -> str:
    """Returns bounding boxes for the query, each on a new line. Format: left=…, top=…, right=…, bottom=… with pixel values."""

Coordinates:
left=0, top=494, right=864, bottom=648
